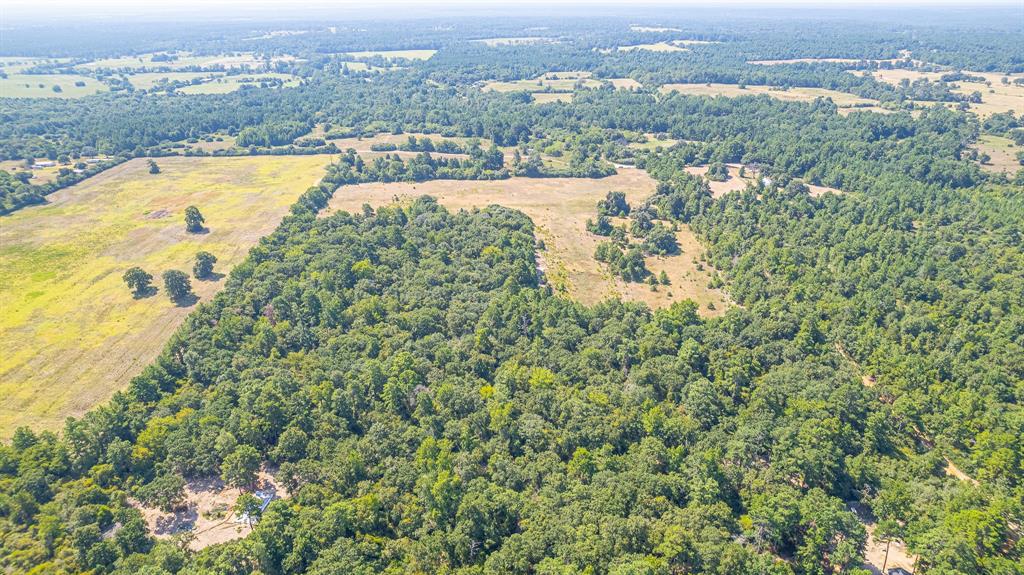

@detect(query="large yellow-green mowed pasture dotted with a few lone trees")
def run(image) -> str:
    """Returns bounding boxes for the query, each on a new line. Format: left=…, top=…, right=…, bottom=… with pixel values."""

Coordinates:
left=0, top=156, right=330, bottom=431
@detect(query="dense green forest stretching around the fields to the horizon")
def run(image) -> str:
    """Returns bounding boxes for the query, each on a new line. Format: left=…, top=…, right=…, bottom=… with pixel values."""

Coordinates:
left=0, top=7, right=1024, bottom=575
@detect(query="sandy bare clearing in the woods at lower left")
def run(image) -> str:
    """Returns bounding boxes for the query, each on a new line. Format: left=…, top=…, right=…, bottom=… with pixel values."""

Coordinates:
left=130, top=470, right=288, bottom=551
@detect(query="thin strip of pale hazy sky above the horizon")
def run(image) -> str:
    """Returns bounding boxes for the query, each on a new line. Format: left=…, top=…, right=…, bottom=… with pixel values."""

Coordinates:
left=0, top=0, right=1024, bottom=23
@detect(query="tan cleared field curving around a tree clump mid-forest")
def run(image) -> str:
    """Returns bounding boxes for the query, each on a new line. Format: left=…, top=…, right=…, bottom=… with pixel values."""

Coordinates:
left=325, top=168, right=728, bottom=315
